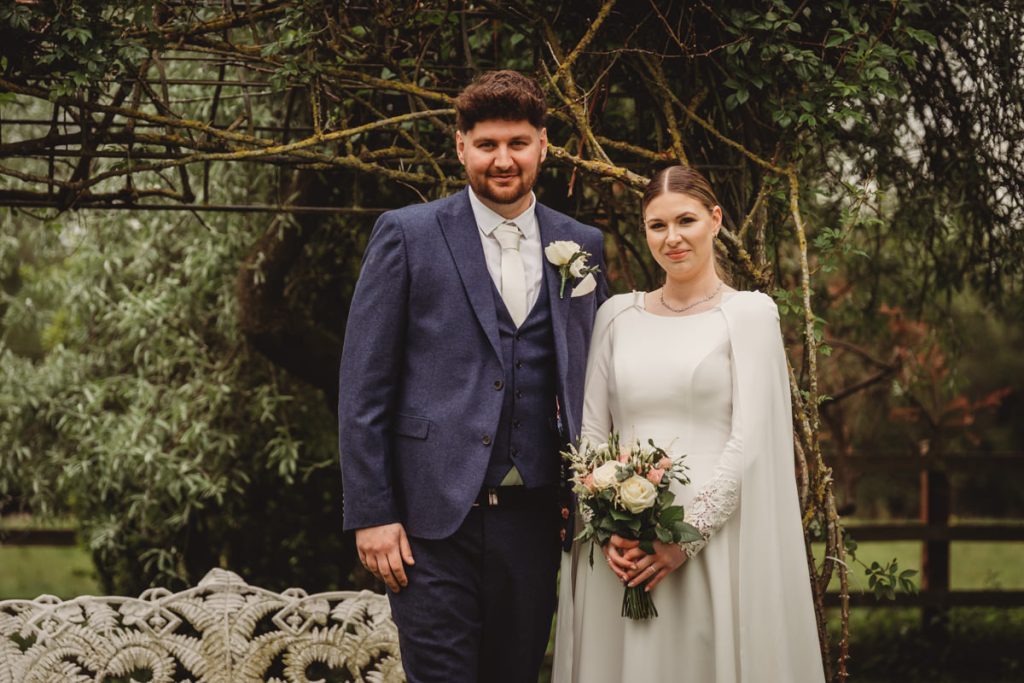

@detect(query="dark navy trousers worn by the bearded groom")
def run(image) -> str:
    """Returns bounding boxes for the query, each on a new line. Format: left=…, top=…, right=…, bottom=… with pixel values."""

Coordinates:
left=388, top=495, right=561, bottom=683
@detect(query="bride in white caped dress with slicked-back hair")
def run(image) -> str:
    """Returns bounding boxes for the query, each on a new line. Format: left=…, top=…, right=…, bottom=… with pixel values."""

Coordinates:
left=553, top=166, right=824, bottom=683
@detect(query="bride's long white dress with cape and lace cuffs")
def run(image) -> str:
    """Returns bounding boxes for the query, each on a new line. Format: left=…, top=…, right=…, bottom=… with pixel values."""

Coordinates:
left=553, top=293, right=823, bottom=683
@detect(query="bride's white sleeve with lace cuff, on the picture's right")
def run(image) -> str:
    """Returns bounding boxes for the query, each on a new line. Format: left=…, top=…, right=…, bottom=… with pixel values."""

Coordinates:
left=682, top=339, right=743, bottom=557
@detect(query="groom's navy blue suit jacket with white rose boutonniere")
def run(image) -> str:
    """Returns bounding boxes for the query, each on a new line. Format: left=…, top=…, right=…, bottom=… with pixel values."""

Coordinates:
left=338, top=190, right=607, bottom=539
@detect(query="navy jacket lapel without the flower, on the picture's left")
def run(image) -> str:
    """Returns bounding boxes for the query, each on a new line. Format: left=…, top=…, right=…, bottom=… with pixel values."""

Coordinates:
left=437, top=189, right=502, bottom=360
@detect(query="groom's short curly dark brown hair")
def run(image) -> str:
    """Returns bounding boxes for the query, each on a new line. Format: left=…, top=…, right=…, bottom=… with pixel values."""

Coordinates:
left=455, top=69, right=548, bottom=133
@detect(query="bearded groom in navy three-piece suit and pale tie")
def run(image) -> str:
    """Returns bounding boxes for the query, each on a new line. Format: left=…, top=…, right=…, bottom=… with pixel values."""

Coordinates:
left=338, top=71, right=607, bottom=683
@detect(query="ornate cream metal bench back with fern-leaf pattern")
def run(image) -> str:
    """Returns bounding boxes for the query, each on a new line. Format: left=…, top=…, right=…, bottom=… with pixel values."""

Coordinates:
left=0, top=569, right=406, bottom=683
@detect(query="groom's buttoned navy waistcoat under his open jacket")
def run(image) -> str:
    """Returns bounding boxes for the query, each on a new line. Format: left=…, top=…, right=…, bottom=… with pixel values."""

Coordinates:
left=484, top=278, right=561, bottom=487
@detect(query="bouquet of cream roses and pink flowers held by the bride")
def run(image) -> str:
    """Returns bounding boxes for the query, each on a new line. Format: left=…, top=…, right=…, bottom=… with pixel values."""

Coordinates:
left=562, top=432, right=701, bottom=620
